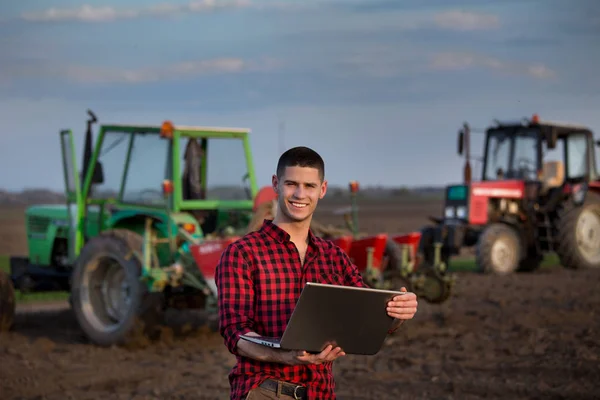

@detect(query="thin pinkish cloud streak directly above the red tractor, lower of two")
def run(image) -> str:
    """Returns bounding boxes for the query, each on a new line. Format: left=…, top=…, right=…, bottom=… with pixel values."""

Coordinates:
left=430, top=52, right=556, bottom=79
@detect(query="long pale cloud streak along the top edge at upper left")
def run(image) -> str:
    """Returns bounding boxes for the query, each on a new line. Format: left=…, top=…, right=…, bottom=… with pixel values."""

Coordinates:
left=21, top=0, right=251, bottom=22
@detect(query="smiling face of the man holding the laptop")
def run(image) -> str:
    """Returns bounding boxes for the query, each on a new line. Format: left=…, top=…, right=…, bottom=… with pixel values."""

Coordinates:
left=273, top=167, right=327, bottom=222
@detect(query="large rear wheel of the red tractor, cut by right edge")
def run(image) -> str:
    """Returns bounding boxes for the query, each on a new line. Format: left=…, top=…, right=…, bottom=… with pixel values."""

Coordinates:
left=556, top=193, right=600, bottom=269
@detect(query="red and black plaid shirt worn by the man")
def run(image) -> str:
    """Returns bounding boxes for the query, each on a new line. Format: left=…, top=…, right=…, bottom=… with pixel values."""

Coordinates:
left=216, top=220, right=367, bottom=399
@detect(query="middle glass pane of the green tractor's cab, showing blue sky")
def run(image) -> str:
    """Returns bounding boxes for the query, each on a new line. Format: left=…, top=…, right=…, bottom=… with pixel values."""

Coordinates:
left=122, top=132, right=171, bottom=206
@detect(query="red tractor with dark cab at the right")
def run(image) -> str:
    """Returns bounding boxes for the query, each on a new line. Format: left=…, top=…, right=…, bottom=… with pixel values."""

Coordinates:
left=419, top=115, right=600, bottom=274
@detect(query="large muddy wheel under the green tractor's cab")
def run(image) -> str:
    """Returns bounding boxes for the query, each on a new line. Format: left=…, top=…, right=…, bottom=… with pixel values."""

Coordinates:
left=72, top=229, right=164, bottom=346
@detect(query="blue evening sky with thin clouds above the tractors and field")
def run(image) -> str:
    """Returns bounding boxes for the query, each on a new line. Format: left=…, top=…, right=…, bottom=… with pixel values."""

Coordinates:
left=0, top=0, right=600, bottom=190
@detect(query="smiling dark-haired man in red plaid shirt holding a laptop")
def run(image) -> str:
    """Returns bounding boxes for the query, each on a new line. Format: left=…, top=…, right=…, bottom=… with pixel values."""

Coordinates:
left=216, top=147, right=417, bottom=400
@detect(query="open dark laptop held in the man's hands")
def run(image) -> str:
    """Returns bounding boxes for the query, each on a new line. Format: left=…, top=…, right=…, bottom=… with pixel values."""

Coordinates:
left=240, top=282, right=405, bottom=355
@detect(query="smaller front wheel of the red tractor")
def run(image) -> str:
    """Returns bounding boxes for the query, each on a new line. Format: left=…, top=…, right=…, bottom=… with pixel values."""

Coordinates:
left=475, top=223, right=522, bottom=275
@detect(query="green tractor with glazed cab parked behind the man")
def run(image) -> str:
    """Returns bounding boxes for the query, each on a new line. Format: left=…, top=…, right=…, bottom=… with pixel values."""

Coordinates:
left=0, top=111, right=257, bottom=346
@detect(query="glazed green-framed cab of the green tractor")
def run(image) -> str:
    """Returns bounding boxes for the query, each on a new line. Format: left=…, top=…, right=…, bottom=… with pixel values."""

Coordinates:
left=61, top=114, right=257, bottom=266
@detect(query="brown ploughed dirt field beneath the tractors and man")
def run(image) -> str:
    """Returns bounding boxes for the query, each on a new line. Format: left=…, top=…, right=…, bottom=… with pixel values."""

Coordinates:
left=0, top=203, right=600, bottom=399
